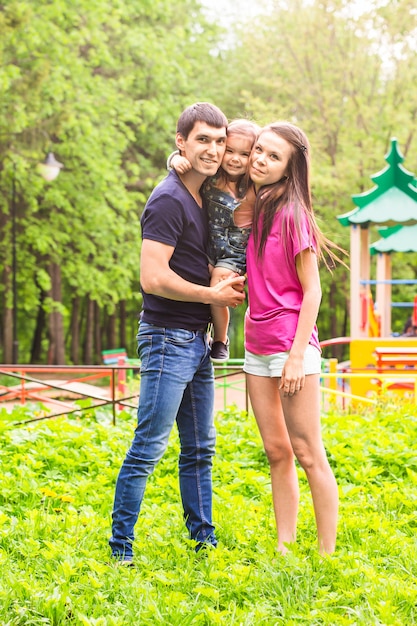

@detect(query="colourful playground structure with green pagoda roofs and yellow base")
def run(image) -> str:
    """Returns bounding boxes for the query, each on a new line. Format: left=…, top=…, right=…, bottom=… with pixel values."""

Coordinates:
left=337, top=138, right=417, bottom=395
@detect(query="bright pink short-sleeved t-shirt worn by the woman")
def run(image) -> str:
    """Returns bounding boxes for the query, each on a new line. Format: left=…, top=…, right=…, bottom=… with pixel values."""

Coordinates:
left=245, top=207, right=320, bottom=355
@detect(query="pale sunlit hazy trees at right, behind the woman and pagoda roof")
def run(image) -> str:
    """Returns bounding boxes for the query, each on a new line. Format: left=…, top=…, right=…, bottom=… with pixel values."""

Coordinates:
left=205, top=0, right=416, bottom=338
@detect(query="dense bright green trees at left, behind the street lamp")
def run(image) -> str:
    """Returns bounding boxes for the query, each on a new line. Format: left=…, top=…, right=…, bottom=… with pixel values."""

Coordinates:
left=0, top=0, right=223, bottom=363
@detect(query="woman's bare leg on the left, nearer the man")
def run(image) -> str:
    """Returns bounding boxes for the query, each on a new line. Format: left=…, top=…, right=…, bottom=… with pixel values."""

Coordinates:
left=246, top=374, right=299, bottom=554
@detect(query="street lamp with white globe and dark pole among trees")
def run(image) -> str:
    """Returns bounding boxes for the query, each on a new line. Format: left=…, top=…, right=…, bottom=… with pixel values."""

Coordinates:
left=11, top=152, right=64, bottom=365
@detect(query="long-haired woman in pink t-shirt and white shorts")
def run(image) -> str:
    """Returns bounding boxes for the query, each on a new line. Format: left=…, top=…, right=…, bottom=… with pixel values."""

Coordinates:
left=244, top=122, right=339, bottom=554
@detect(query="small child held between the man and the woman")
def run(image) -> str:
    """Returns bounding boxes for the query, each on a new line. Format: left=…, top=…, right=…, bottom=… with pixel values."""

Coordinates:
left=167, top=120, right=259, bottom=363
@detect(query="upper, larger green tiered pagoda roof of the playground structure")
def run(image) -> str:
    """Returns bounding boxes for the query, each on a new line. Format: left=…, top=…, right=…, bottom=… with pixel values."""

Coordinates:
left=337, top=139, right=417, bottom=226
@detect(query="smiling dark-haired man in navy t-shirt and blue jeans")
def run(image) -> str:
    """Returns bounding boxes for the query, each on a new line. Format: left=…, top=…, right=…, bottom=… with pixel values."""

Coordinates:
left=109, top=102, right=245, bottom=565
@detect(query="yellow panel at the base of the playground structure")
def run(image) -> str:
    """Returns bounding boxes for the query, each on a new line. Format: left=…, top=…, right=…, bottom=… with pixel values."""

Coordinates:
left=350, top=337, right=417, bottom=396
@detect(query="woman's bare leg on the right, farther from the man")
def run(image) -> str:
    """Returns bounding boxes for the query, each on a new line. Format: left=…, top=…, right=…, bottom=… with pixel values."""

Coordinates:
left=281, top=374, right=339, bottom=554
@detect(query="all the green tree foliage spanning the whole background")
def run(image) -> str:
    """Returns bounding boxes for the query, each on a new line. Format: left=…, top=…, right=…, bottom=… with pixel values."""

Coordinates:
left=0, top=0, right=417, bottom=362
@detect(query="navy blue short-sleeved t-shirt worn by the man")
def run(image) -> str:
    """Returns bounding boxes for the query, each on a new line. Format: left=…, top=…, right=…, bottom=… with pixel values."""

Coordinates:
left=141, top=170, right=210, bottom=330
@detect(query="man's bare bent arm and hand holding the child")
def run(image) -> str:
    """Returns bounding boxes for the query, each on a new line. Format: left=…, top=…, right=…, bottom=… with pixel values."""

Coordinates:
left=140, top=239, right=245, bottom=307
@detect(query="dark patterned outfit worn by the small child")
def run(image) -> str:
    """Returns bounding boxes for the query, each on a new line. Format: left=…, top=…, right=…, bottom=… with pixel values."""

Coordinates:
left=202, top=178, right=251, bottom=274
